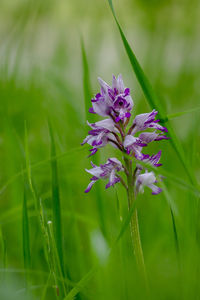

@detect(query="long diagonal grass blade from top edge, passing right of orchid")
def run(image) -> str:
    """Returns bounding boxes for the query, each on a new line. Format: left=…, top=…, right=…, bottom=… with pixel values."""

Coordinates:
left=108, top=0, right=196, bottom=185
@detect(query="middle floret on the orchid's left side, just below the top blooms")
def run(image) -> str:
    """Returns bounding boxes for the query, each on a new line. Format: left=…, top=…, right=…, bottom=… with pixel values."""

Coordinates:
left=82, top=119, right=118, bottom=155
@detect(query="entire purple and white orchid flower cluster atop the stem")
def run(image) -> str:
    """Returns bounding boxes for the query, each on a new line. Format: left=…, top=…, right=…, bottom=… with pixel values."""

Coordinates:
left=82, top=75, right=168, bottom=194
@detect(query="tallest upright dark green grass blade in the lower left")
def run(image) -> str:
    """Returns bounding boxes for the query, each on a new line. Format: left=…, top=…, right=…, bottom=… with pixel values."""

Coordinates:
left=49, top=121, right=64, bottom=276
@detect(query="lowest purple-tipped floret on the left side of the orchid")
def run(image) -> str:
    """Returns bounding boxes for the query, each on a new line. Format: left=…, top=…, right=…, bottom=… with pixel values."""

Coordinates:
left=85, top=157, right=123, bottom=193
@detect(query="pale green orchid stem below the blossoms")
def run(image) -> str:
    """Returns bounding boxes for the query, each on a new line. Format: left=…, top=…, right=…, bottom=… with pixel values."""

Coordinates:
left=125, top=159, right=148, bottom=289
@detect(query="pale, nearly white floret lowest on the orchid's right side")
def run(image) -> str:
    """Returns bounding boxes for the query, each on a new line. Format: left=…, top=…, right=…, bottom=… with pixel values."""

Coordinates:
left=136, top=171, right=162, bottom=195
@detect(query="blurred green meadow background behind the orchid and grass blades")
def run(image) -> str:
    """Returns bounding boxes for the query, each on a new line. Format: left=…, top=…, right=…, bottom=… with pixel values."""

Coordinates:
left=0, top=0, right=200, bottom=300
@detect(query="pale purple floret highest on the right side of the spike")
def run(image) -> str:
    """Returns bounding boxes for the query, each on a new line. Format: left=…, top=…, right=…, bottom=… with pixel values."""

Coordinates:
left=131, top=109, right=168, bottom=135
